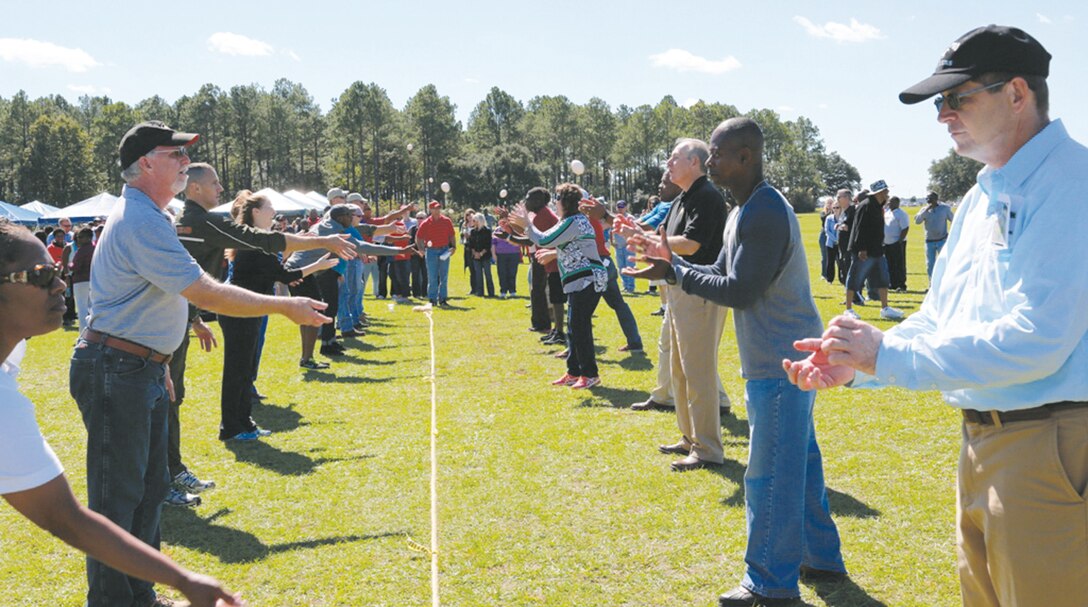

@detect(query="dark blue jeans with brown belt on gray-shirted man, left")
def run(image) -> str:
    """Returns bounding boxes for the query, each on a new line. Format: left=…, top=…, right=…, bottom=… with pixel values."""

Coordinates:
left=69, top=339, right=170, bottom=607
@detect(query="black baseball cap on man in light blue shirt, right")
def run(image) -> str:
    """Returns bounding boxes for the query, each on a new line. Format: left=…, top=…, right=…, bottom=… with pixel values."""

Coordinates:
left=899, top=25, right=1050, bottom=103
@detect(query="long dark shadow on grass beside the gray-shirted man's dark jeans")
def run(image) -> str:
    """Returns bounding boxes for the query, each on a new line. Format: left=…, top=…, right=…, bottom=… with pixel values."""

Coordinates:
left=162, top=508, right=405, bottom=563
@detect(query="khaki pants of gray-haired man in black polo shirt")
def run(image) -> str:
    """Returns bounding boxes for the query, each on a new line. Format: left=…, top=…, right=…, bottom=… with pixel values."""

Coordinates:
left=665, top=288, right=726, bottom=463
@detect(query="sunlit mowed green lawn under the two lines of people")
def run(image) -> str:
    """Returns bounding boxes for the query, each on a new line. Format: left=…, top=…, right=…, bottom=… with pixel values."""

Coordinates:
left=0, top=210, right=960, bottom=607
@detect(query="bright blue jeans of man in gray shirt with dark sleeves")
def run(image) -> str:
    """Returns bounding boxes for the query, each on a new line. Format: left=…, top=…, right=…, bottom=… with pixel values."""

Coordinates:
left=741, top=379, right=846, bottom=598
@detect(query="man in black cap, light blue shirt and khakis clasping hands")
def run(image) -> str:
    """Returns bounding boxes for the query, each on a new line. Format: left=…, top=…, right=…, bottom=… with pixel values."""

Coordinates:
left=783, top=25, right=1088, bottom=607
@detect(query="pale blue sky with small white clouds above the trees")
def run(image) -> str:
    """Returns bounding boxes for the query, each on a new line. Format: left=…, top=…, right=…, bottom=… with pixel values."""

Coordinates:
left=0, top=0, right=1088, bottom=196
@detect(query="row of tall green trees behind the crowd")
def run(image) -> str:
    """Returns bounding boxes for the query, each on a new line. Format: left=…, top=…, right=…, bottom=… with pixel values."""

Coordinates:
left=0, top=79, right=861, bottom=211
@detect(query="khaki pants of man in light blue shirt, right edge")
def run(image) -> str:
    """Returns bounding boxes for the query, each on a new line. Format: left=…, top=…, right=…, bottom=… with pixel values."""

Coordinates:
left=956, top=409, right=1088, bottom=607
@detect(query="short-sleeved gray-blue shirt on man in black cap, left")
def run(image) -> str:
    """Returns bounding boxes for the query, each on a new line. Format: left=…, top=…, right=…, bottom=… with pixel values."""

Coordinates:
left=90, top=186, right=203, bottom=354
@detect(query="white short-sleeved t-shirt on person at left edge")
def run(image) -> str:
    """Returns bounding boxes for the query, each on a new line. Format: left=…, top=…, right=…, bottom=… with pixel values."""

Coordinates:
left=0, top=342, right=64, bottom=495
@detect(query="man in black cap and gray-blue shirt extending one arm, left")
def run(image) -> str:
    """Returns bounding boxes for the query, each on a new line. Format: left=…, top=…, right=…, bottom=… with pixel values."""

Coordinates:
left=70, top=122, right=329, bottom=607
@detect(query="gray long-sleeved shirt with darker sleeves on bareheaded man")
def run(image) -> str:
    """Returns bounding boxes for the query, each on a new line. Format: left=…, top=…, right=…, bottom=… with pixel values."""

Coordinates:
left=672, top=182, right=824, bottom=380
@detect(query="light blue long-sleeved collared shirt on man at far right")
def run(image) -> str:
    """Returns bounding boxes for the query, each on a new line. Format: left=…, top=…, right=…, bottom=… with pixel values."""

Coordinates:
left=854, top=121, right=1088, bottom=411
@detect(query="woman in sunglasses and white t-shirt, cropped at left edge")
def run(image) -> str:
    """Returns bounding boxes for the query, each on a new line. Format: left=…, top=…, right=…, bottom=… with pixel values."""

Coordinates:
left=0, top=220, right=243, bottom=607
